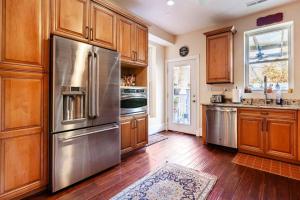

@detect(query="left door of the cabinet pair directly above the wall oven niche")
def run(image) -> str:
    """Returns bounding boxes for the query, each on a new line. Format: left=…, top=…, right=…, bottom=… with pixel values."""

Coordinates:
left=118, top=17, right=136, bottom=63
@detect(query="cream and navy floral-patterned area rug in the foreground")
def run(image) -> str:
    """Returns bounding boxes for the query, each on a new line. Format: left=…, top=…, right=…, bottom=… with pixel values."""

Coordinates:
left=112, top=164, right=217, bottom=200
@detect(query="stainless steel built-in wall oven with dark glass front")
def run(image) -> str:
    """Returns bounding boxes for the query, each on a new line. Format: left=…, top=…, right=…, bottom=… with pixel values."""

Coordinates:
left=121, top=86, right=147, bottom=115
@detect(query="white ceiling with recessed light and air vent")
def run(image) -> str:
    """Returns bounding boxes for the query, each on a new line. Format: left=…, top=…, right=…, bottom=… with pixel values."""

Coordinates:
left=111, top=0, right=297, bottom=35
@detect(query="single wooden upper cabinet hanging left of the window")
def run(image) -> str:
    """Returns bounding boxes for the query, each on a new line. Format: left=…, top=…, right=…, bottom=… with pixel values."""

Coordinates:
left=204, top=26, right=236, bottom=84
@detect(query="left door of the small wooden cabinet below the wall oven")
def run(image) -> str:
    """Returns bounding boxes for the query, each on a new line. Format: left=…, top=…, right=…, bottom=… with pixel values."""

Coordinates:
left=121, top=120, right=133, bottom=153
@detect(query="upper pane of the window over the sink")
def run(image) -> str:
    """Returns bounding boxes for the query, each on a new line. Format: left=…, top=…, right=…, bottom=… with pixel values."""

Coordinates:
left=248, top=28, right=289, bottom=63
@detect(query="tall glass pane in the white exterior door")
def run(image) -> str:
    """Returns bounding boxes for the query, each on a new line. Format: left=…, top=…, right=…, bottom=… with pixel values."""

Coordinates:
left=173, top=66, right=191, bottom=125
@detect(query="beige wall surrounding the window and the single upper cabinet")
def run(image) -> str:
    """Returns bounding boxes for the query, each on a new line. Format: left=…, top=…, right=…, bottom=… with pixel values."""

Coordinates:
left=166, top=2, right=300, bottom=134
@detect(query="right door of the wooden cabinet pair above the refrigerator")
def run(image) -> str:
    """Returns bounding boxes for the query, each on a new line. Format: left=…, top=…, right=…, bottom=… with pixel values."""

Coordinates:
left=90, top=2, right=117, bottom=50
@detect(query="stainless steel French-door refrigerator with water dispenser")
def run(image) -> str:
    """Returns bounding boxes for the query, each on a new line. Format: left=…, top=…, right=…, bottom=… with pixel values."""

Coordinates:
left=50, top=36, right=120, bottom=192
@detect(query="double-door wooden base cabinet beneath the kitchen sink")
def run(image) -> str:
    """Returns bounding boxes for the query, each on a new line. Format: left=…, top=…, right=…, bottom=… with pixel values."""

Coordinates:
left=238, top=109, right=298, bottom=160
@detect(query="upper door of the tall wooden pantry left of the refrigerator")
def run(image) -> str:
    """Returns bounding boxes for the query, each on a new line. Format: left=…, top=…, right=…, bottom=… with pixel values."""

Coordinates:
left=0, top=0, right=47, bottom=71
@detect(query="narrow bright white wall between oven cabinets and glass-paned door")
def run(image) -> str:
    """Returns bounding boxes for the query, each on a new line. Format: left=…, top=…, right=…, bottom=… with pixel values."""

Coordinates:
left=149, top=42, right=166, bottom=135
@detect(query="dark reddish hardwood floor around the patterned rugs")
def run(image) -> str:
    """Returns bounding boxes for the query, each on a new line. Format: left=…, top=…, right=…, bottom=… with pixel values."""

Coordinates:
left=29, top=132, right=300, bottom=200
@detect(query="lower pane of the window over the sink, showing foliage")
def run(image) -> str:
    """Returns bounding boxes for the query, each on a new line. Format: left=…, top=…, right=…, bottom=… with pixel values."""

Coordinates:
left=249, top=61, right=289, bottom=90
